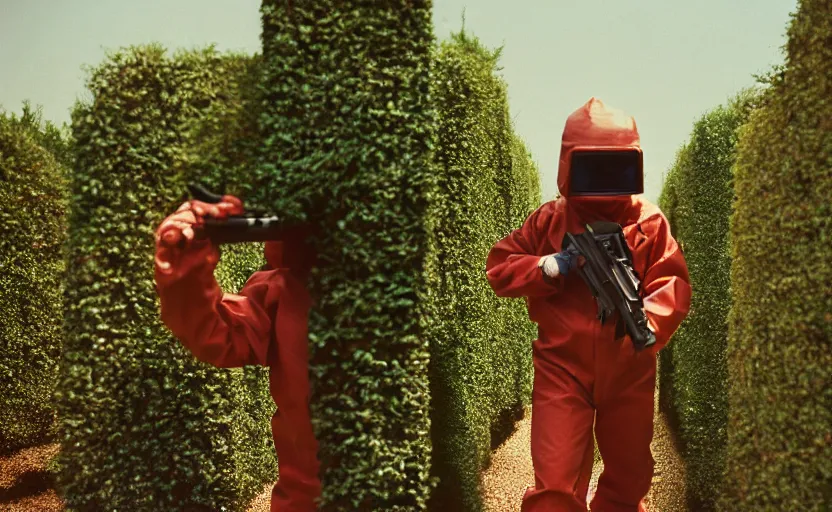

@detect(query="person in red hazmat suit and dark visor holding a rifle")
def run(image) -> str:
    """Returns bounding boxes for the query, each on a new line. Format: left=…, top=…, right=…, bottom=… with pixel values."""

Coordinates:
left=486, top=98, right=691, bottom=512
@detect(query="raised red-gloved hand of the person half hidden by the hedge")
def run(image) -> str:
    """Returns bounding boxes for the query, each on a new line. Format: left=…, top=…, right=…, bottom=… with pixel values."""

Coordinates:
left=156, top=195, right=244, bottom=280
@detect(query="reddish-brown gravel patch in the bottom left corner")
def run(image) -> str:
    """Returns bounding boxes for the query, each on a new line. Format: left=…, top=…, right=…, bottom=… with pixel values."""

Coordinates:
left=0, top=444, right=64, bottom=512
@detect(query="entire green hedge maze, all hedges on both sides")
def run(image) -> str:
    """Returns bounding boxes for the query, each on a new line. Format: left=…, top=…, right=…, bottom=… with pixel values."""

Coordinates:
left=0, top=0, right=832, bottom=511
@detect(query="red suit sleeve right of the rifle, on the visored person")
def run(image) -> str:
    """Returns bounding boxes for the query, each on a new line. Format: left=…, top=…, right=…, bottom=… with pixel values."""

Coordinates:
left=644, top=216, right=691, bottom=353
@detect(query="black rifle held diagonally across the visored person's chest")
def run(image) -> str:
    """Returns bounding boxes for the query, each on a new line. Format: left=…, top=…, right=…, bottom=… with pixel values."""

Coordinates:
left=563, top=222, right=656, bottom=352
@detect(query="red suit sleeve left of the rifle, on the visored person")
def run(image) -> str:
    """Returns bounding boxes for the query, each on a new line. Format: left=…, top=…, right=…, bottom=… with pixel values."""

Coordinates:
left=486, top=207, right=563, bottom=297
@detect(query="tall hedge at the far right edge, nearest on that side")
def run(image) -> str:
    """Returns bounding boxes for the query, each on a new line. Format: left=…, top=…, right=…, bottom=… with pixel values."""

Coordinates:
left=720, top=0, right=832, bottom=511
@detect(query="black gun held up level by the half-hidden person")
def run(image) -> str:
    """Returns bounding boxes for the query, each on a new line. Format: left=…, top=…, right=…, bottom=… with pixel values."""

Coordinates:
left=188, top=183, right=285, bottom=245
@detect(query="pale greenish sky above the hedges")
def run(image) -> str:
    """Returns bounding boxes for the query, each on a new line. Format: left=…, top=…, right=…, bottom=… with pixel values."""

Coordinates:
left=0, top=0, right=797, bottom=201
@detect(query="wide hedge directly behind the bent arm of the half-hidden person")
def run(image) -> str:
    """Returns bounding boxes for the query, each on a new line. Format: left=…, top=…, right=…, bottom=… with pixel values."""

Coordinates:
left=56, top=45, right=275, bottom=511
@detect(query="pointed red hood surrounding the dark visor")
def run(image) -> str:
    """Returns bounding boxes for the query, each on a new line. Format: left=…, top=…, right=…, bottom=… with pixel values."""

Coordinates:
left=558, top=98, right=641, bottom=220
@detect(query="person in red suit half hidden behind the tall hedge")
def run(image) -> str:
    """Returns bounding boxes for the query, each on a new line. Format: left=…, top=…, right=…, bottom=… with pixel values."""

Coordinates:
left=155, top=195, right=321, bottom=512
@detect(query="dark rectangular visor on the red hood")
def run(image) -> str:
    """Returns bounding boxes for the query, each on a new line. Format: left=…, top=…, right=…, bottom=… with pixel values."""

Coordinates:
left=569, top=151, right=644, bottom=196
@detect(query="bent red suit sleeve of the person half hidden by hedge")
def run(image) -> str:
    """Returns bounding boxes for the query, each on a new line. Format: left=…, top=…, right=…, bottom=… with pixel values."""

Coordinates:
left=155, top=244, right=277, bottom=368
